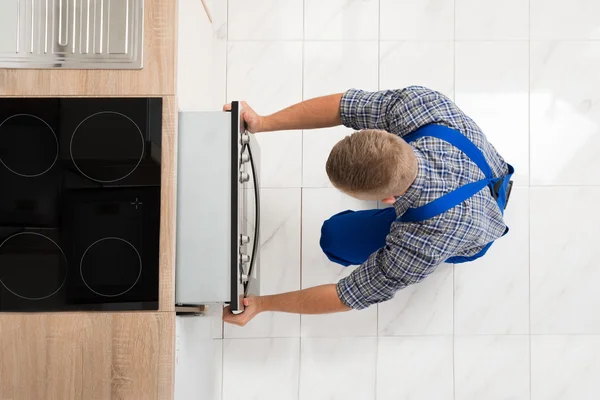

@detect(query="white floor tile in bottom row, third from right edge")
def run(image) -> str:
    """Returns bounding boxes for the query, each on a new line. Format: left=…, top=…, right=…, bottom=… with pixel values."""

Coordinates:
left=377, top=336, right=454, bottom=400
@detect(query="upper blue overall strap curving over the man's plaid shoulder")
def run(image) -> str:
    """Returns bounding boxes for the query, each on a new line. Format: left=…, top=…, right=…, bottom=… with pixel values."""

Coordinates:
left=403, top=124, right=494, bottom=178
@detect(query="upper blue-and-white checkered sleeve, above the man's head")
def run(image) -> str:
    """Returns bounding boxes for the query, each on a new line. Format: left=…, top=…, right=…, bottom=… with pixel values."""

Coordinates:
left=340, top=86, right=466, bottom=136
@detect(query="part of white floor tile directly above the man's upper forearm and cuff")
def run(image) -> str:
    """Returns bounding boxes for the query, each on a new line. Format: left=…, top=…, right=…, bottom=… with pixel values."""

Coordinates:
left=304, top=41, right=377, bottom=99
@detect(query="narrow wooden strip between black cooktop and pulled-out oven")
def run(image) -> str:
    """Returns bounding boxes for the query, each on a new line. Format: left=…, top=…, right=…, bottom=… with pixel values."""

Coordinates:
left=159, top=96, right=177, bottom=311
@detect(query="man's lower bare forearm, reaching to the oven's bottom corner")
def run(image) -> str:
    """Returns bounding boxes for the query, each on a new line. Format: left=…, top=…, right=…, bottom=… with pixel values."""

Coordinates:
left=260, top=284, right=351, bottom=314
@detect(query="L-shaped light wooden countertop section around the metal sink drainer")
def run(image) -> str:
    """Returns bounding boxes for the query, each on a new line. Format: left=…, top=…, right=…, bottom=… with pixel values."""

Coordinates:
left=0, top=0, right=177, bottom=96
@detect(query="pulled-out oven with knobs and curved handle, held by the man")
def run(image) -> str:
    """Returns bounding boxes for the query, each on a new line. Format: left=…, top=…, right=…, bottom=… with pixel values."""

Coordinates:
left=175, top=101, right=260, bottom=312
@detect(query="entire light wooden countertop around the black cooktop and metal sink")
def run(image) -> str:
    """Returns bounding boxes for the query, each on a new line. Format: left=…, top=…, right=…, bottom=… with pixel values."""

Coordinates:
left=0, top=0, right=177, bottom=400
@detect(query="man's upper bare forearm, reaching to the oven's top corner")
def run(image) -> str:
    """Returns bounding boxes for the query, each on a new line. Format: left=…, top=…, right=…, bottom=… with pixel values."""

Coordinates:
left=261, top=93, right=342, bottom=132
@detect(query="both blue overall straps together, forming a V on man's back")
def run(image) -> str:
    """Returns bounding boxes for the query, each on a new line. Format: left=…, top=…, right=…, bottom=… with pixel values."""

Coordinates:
left=397, top=124, right=494, bottom=222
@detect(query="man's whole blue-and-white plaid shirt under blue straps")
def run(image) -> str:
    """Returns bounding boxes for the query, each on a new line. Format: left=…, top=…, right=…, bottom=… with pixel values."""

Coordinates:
left=337, top=86, right=508, bottom=309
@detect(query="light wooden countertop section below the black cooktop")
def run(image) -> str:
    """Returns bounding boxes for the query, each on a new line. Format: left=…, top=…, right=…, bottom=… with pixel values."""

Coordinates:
left=0, top=313, right=175, bottom=400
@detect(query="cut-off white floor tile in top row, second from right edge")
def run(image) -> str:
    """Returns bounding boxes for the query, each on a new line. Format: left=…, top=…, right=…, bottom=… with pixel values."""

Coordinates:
left=455, top=0, right=529, bottom=40
